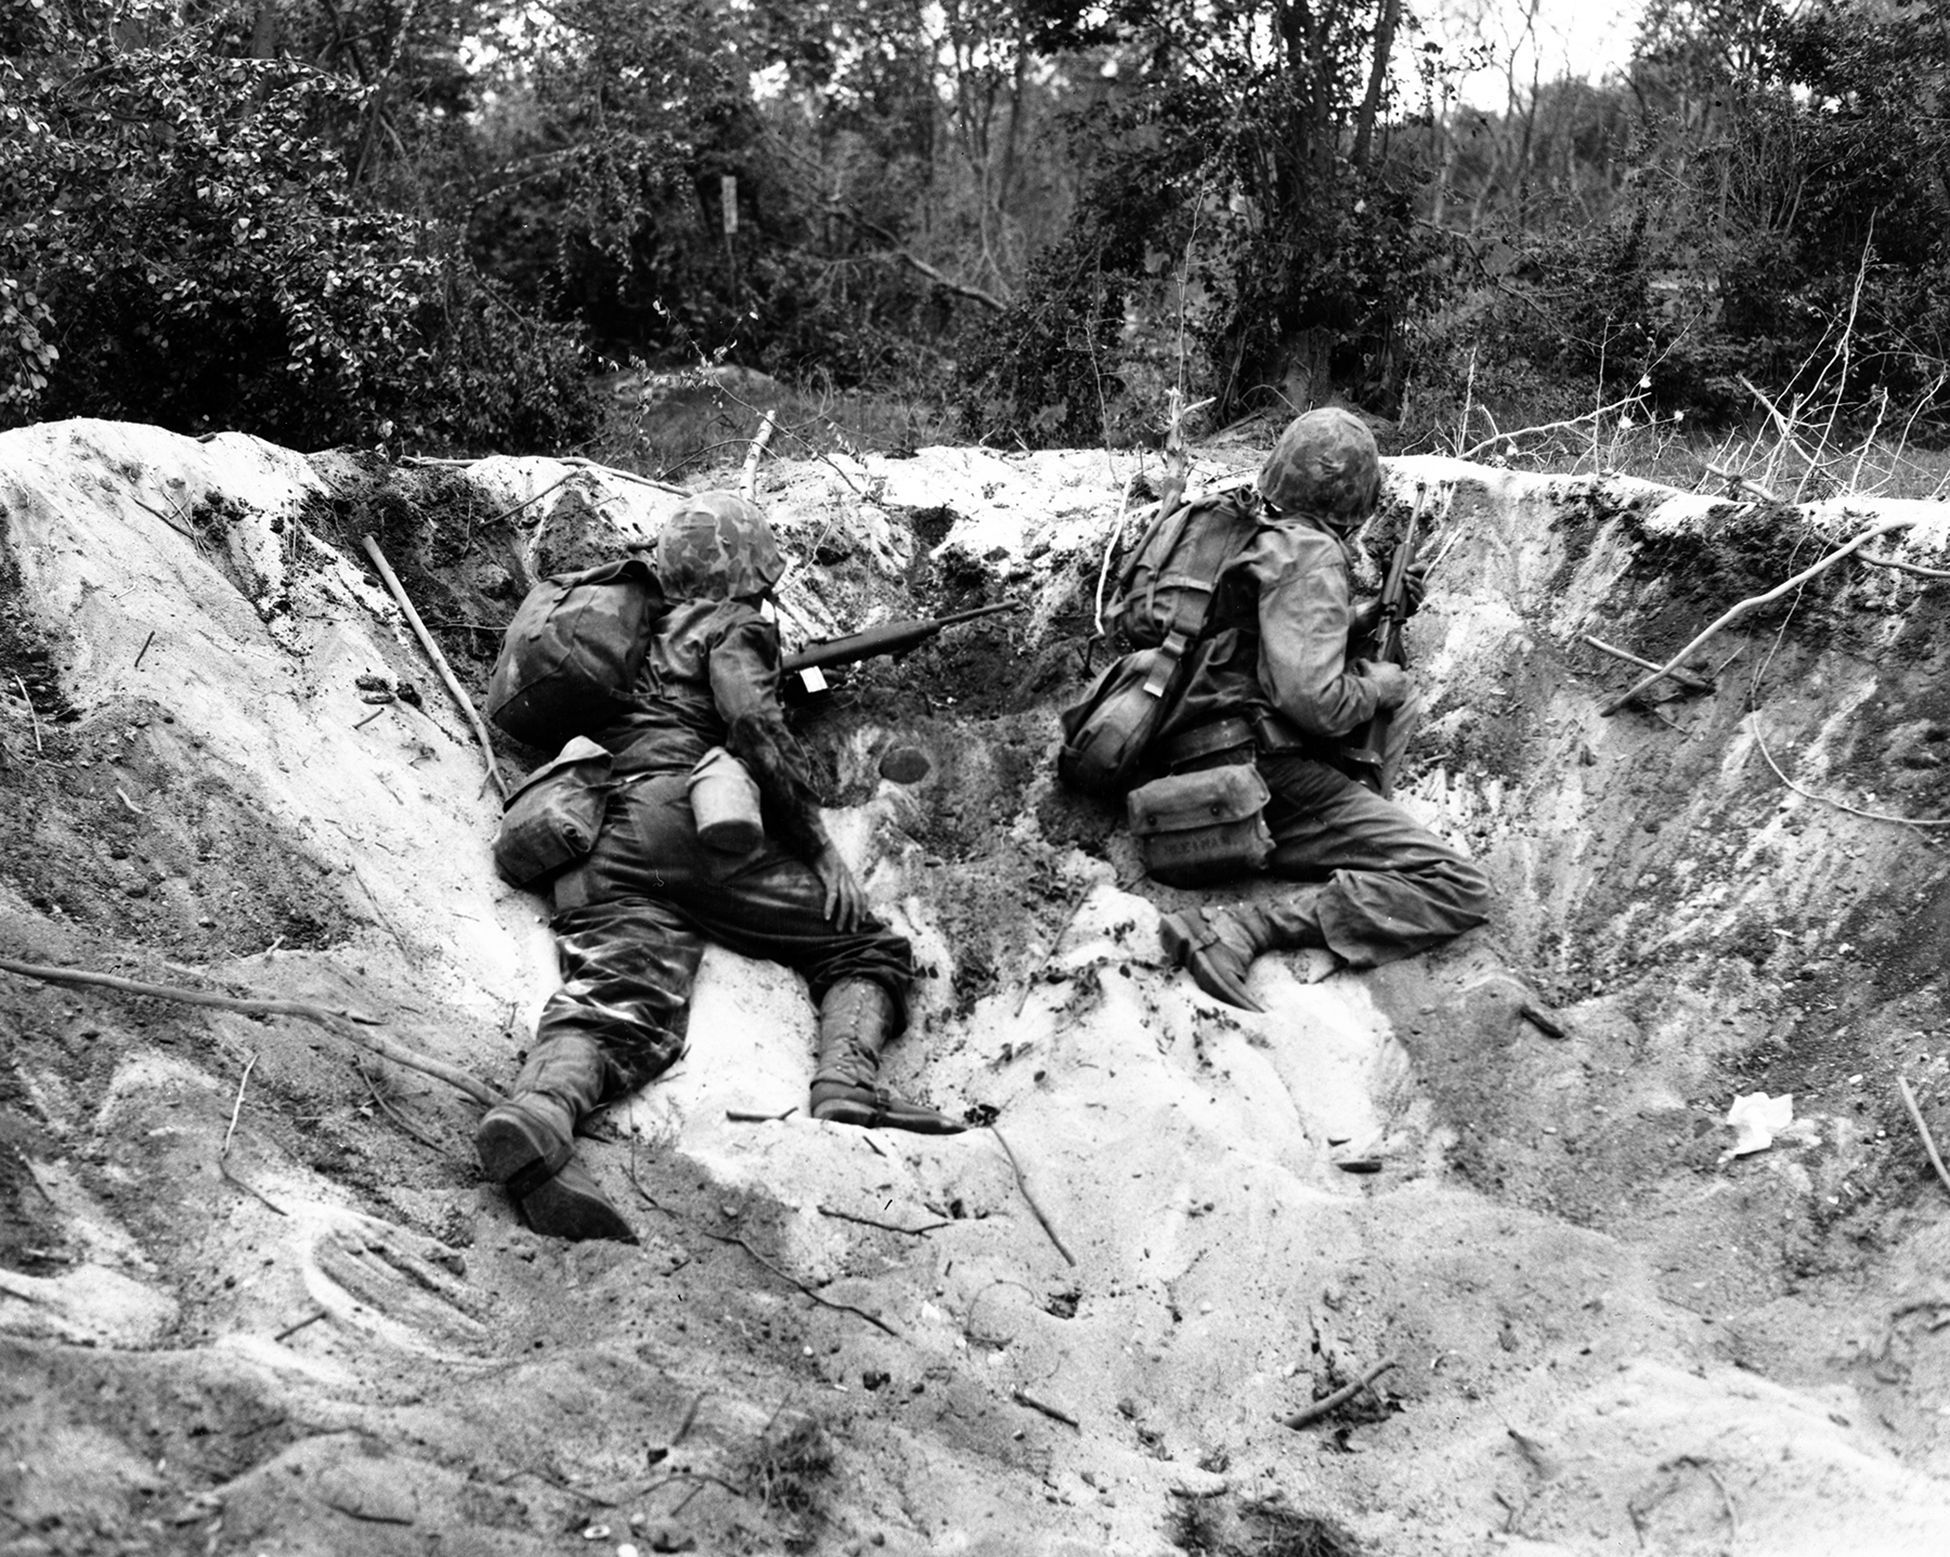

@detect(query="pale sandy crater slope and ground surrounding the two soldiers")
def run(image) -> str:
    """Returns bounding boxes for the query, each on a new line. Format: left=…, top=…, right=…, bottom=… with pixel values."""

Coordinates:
left=0, top=423, right=1950, bottom=1557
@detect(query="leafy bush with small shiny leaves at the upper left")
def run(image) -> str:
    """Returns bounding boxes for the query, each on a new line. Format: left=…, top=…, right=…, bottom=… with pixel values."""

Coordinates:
left=0, top=6, right=591, bottom=447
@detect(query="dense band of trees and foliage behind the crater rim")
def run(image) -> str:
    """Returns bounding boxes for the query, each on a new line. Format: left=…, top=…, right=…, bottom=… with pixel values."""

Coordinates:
left=11, top=0, right=1950, bottom=451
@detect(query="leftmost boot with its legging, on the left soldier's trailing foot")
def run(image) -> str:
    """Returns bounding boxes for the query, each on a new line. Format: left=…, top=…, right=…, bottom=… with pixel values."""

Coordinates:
left=474, top=1032, right=636, bottom=1243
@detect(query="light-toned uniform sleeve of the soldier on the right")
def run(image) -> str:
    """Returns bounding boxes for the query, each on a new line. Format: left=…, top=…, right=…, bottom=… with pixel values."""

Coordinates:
left=1256, top=527, right=1379, bottom=738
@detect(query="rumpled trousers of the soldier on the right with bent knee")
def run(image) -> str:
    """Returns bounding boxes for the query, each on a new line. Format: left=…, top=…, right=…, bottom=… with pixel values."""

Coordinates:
left=1258, top=699, right=1490, bottom=968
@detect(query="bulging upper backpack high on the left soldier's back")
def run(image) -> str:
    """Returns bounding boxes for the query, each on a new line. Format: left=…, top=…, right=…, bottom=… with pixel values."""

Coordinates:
left=488, top=556, right=665, bottom=747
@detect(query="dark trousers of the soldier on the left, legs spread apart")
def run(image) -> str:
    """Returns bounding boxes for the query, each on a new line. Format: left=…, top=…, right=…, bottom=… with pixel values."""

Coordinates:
left=534, top=773, right=913, bottom=1100
